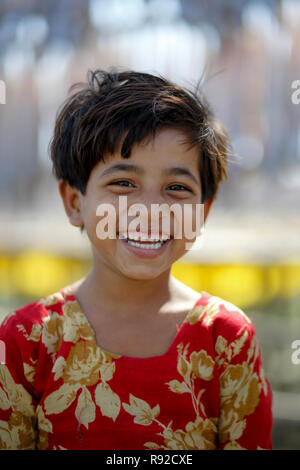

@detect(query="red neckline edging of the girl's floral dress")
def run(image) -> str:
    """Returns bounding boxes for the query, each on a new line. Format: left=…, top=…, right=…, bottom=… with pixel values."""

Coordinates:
left=60, top=286, right=203, bottom=361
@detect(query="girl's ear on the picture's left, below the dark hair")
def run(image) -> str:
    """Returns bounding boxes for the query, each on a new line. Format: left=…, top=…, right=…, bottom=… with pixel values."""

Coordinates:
left=58, top=180, right=84, bottom=227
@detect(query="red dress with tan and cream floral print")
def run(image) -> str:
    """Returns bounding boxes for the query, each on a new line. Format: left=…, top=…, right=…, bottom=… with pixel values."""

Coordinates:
left=0, top=287, right=273, bottom=450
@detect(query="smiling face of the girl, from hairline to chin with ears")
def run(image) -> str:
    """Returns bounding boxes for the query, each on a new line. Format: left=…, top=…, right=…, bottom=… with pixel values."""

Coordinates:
left=59, top=129, right=212, bottom=280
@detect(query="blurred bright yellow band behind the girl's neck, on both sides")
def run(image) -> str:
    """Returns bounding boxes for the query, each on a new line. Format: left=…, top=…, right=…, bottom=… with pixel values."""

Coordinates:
left=0, top=250, right=300, bottom=309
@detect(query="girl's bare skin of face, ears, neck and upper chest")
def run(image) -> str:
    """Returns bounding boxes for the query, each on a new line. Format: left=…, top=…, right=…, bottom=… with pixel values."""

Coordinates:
left=59, top=129, right=213, bottom=357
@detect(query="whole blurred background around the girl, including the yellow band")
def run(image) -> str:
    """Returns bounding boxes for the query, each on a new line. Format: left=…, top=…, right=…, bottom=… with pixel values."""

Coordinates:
left=0, top=0, right=300, bottom=449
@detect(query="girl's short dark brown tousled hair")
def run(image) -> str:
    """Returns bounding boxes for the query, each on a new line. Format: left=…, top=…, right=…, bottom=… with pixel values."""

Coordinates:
left=50, top=70, right=231, bottom=203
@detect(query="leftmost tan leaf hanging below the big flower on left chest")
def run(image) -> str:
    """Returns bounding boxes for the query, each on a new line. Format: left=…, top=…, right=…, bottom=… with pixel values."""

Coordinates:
left=44, top=383, right=80, bottom=415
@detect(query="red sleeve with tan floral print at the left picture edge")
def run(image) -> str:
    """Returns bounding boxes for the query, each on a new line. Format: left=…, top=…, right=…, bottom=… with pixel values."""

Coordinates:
left=0, top=312, right=37, bottom=450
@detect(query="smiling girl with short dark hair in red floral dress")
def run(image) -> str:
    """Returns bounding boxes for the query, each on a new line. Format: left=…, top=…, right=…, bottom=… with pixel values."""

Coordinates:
left=0, top=71, right=273, bottom=450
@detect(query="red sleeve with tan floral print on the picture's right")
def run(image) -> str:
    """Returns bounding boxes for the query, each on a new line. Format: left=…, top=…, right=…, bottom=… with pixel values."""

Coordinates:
left=216, top=322, right=273, bottom=450
